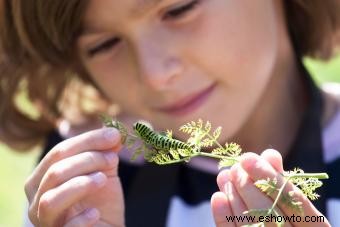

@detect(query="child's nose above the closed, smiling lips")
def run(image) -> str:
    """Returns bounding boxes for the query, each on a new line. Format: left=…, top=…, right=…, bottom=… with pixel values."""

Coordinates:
left=136, top=34, right=183, bottom=91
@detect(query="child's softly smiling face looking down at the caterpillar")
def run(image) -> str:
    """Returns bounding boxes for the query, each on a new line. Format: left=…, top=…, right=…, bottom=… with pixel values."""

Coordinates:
left=77, top=0, right=283, bottom=140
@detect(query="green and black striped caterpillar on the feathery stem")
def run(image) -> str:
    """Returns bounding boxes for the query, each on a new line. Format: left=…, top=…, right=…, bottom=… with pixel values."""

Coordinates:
left=133, top=122, right=191, bottom=150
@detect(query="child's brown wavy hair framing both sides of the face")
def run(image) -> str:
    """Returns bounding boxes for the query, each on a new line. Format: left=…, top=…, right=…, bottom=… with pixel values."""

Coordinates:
left=0, top=0, right=340, bottom=150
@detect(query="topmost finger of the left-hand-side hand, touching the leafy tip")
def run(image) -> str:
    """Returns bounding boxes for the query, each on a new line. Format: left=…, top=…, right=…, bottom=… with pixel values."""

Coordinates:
left=25, top=128, right=121, bottom=201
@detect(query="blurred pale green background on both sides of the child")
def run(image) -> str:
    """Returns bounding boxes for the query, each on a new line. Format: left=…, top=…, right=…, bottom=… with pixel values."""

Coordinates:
left=0, top=56, right=340, bottom=227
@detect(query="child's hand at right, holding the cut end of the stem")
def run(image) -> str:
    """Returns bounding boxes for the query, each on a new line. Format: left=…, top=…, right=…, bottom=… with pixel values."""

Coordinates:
left=211, top=149, right=330, bottom=227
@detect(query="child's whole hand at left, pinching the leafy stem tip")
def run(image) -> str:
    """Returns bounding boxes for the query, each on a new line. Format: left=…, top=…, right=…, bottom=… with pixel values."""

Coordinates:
left=25, top=128, right=125, bottom=227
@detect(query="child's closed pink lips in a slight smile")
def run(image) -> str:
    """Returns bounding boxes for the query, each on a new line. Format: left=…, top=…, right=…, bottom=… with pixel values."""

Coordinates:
left=158, top=83, right=217, bottom=116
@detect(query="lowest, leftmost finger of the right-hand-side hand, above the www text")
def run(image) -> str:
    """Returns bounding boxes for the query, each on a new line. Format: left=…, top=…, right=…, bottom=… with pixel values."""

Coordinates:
left=211, top=192, right=235, bottom=227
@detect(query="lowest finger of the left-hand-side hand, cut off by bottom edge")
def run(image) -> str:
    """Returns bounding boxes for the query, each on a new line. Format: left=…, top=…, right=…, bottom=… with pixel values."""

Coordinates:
left=64, top=208, right=100, bottom=227
